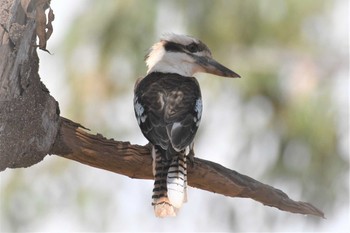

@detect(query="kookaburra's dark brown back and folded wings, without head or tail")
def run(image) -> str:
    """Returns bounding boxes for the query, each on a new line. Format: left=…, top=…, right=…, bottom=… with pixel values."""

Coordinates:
left=134, top=72, right=202, bottom=153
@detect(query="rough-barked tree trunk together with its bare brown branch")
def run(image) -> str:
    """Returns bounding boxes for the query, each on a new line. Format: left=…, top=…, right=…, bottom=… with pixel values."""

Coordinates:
left=0, top=0, right=324, bottom=217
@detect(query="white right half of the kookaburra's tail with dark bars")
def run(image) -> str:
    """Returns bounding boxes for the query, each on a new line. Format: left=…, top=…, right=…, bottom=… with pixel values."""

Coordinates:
left=167, top=152, right=187, bottom=209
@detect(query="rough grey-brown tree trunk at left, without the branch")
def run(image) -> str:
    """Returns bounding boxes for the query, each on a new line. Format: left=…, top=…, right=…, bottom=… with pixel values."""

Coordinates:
left=0, top=0, right=59, bottom=171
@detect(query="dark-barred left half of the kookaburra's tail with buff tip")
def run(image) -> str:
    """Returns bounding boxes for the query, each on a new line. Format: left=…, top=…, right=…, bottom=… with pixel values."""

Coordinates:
left=152, top=146, right=177, bottom=217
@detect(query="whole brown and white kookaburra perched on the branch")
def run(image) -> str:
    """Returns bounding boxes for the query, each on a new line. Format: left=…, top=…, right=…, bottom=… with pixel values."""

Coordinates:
left=134, top=34, right=240, bottom=217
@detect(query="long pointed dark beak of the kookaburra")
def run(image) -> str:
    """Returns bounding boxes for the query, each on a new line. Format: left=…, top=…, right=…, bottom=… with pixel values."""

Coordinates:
left=194, top=56, right=241, bottom=78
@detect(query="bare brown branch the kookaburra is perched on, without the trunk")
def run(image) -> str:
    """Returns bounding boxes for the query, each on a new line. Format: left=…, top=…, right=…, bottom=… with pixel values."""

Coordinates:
left=50, top=117, right=324, bottom=217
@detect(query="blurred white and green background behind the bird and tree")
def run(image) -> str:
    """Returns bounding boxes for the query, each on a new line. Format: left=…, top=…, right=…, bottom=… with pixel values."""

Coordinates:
left=0, top=0, right=350, bottom=232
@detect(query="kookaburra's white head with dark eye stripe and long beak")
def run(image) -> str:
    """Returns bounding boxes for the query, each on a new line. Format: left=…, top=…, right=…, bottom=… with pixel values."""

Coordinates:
left=145, top=33, right=240, bottom=78
